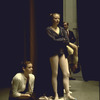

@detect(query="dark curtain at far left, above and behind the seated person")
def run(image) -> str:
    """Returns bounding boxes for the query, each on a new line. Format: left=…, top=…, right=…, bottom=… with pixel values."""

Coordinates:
left=0, top=0, right=30, bottom=87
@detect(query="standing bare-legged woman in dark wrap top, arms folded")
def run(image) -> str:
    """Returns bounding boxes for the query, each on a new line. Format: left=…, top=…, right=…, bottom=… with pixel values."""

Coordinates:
left=46, top=13, right=75, bottom=100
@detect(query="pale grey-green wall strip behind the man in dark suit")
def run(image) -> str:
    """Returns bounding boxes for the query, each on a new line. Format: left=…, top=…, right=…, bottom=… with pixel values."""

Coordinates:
left=63, top=0, right=79, bottom=45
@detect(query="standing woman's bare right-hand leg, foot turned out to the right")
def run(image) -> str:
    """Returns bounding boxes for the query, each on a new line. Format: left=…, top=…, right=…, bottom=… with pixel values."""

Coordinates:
left=59, top=54, right=75, bottom=100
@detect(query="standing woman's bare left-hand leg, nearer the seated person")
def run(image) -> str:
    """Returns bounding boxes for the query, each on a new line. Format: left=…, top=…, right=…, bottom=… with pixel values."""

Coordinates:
left=50, top=55, right=59, bottom=99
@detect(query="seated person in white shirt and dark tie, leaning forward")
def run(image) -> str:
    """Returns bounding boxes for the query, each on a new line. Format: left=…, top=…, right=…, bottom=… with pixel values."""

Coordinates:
left=9, top=61, right=35, bottom=100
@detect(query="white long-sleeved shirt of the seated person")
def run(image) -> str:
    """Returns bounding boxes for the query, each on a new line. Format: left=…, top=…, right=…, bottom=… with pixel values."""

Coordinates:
left=10, top=73, right=35, bottom=97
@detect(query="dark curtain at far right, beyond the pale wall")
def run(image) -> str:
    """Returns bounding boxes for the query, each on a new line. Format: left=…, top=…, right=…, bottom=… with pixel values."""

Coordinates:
left=77, top=0, right=100, bottom=81
